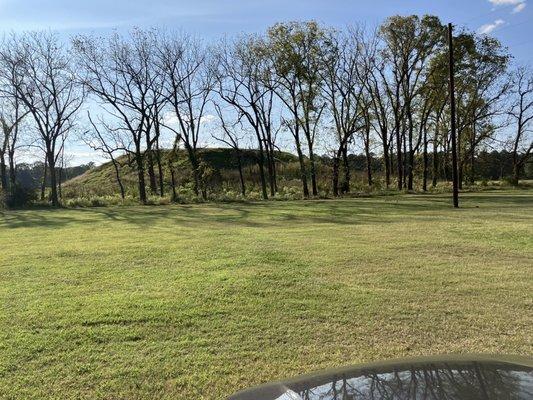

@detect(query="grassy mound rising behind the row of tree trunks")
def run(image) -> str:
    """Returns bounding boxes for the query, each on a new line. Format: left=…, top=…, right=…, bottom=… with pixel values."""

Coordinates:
left=62, top=148, right=298, bottom=198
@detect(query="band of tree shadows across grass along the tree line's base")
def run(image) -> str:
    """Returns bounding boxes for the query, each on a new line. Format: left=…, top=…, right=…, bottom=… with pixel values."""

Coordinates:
left=0, top=193, right=533, bottom=228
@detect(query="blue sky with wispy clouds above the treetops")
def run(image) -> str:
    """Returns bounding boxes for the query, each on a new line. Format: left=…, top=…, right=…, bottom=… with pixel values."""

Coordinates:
left=0, top=0, right=533, bottom=163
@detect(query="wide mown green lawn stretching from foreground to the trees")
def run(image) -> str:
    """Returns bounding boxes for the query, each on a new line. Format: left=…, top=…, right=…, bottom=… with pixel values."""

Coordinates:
left=0, top=191, right=533, bottom=399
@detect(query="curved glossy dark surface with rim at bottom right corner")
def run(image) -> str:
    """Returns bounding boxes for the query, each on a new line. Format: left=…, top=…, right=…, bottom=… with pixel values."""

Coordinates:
left=230, top=356, right=533, bottom=400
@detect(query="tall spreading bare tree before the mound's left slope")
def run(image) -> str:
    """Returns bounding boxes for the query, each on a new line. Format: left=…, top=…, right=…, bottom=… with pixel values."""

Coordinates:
left=74, top=29, right=164, bottom=204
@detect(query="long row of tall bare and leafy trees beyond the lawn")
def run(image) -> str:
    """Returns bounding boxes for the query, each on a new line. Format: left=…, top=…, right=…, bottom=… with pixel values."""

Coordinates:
left=0, top=16, right=533, bottom=206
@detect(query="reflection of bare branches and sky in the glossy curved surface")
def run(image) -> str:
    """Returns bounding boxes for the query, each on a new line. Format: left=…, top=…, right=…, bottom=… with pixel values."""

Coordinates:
left=294, top=362, right=533, bottom=400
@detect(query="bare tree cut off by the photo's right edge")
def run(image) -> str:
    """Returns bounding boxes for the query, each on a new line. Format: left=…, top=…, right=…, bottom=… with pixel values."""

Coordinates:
left=509, top=66, right=533, bottom=185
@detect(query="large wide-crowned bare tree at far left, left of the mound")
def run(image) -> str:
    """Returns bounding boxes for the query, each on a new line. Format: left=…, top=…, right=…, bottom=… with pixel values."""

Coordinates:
left=0, top=32, right=84, bottom=206
